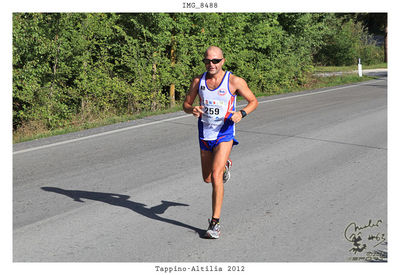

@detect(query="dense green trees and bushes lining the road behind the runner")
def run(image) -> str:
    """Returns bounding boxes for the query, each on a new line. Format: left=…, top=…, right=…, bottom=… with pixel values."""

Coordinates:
left=13, top=13, right=383, bottom=133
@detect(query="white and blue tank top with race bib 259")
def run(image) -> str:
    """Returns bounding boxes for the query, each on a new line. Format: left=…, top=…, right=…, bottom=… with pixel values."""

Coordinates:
left=198, top=71, right=236, bottom=140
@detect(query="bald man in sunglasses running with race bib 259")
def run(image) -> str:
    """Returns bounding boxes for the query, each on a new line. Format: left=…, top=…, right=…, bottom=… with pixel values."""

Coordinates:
left=183, top=46, right=258, bottom=239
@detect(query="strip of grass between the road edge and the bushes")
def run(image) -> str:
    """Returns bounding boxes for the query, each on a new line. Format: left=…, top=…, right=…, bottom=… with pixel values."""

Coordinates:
left=13, top=73, right=374, bottom=143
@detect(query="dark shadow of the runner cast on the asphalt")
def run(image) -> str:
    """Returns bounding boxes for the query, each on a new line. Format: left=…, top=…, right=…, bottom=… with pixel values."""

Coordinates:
left=41, top=187, right=205, bottom=237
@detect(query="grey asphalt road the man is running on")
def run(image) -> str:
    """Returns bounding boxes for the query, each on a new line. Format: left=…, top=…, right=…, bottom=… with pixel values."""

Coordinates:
left=13, top=78, right=387, bottom=262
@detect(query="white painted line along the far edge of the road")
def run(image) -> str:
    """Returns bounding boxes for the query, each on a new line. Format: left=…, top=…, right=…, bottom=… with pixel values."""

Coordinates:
left=13, top=80, right=384, bottom=155
